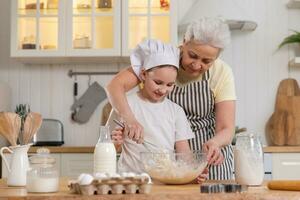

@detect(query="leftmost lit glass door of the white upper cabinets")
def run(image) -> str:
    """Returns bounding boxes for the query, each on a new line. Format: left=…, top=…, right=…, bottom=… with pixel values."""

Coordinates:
left=11, top=0, right=64, bottom=57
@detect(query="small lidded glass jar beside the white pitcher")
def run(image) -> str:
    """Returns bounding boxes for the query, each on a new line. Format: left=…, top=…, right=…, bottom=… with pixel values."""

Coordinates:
left=26, top=148, right=59, bottom=192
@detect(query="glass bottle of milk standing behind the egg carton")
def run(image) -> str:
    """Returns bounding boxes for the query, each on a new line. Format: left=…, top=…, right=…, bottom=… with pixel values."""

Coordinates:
left=94, top=126, right=117, bottom=174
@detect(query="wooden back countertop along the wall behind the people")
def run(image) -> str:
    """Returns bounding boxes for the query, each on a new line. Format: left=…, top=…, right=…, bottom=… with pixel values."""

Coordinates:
left=28, top=146, right=300, bottom=153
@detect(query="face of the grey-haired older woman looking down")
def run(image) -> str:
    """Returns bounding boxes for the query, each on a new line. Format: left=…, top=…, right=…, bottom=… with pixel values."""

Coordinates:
left=181, top=41, right=220, bottom=77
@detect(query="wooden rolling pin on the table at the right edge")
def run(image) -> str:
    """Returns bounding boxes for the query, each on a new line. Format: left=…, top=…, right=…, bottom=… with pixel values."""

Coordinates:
left=268, top=180, right=300, bottom=191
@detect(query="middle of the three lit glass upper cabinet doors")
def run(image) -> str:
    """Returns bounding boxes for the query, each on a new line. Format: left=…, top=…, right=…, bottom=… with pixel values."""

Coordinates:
left=67, top=0, right=121, bottom=56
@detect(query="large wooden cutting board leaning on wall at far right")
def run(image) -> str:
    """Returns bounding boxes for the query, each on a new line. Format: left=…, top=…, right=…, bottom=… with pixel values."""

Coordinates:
left=266, top=79, right=300, bottom=146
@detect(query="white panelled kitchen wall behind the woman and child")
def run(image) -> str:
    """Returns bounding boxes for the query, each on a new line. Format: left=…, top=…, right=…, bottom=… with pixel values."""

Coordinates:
left=0, top=0, right=300, bottom=146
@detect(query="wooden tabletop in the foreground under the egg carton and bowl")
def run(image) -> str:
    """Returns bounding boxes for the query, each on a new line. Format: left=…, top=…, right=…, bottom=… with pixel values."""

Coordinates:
left=0, top=178, right=300, bottom=200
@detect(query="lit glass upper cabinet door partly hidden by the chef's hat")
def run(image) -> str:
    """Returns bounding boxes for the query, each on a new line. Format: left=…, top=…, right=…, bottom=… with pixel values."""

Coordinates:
left=122, top=0, right=177, bottom=56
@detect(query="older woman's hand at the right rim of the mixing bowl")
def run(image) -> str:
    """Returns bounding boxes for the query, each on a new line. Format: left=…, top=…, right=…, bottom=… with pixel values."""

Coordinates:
left=203, top=139, right=224, bottom=165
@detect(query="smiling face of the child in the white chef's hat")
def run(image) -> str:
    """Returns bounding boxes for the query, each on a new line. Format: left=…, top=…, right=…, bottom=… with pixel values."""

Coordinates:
left=141, top=65, right=177, bottom=102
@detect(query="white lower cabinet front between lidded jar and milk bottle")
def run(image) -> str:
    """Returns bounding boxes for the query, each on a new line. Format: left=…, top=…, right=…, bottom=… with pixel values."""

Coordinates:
left=61, top=153, right=94, bottom=178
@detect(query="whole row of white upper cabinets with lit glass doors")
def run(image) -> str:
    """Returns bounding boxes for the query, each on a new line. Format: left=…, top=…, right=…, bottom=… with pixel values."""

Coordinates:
left=11, top=0, right=177, bottom=58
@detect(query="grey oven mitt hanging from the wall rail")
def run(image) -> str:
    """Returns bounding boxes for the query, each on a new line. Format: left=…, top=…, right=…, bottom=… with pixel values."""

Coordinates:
left=71, top=82, right=107, bottom=124
